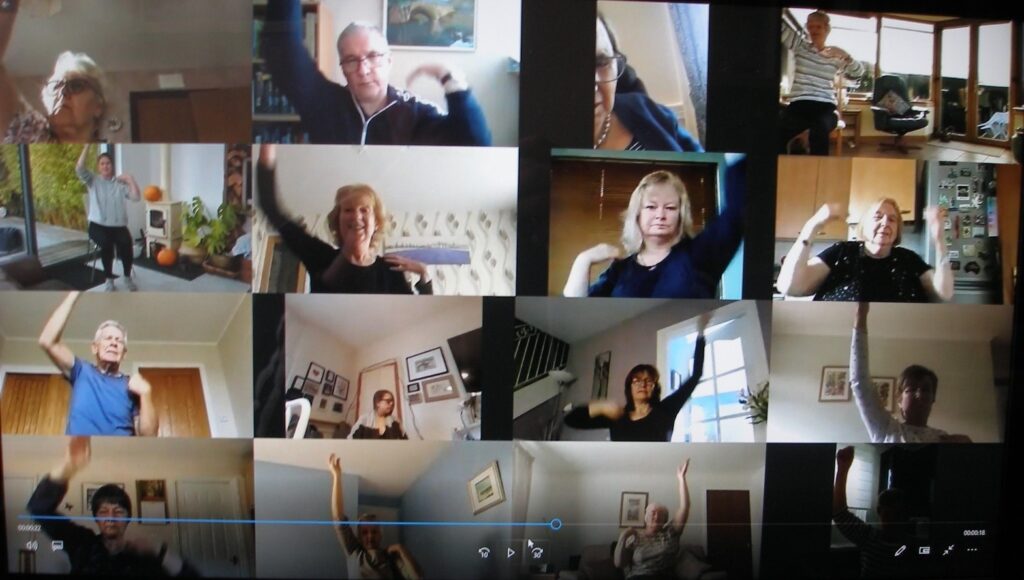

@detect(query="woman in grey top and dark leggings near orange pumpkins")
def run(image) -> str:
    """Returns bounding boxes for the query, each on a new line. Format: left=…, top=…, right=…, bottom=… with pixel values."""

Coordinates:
left=75, top=144, right=142, bottom=292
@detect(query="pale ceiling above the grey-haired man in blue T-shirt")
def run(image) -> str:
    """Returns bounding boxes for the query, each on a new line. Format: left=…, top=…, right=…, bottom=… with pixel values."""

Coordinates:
left=0, top=292, right=245, bottom=343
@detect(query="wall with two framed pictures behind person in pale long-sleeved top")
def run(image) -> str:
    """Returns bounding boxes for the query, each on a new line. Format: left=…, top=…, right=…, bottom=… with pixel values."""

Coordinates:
left=768, top=334, right=1002, bottom=443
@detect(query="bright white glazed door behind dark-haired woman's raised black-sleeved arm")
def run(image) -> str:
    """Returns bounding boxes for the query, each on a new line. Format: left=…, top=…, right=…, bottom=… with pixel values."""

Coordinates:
left=658, top=302, right=768, bottom=443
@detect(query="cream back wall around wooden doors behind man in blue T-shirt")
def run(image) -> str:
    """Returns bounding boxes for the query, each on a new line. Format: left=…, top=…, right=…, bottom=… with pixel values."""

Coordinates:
left=3, top=339, right=244, bottom=438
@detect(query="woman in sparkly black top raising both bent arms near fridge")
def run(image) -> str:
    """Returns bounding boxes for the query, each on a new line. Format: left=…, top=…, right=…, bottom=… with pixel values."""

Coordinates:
left=777, top=198, right=953, bottom=302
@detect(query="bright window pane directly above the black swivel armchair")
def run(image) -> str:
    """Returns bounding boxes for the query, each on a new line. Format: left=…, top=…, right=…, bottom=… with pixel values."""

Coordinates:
left=879, top=17, right=935, bottom=99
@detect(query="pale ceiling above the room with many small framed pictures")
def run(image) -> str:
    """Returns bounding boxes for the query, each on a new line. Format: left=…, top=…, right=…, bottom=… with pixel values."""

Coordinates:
left=285, top=294, right=482, bottom=345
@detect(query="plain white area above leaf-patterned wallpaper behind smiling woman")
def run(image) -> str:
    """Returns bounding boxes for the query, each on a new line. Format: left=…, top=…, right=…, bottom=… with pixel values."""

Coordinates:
left=278, top=146, right=519, bottom=214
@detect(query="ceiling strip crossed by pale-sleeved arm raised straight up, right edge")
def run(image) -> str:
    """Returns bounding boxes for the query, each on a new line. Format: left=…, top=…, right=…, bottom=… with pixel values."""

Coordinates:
left=772, top=301, right=1014, bottom=343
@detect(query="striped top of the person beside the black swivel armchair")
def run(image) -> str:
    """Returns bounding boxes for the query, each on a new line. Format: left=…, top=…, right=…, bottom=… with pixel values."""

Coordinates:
left=782, top=25, right=864, bottom=105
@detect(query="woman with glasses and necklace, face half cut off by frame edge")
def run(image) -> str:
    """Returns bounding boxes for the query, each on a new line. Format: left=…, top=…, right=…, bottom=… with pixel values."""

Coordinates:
left=594, top=15, right=703, bottom=151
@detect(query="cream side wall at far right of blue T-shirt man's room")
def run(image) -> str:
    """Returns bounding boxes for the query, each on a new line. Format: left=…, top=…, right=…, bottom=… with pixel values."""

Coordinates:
left=217, top=294, right=253, bottom=438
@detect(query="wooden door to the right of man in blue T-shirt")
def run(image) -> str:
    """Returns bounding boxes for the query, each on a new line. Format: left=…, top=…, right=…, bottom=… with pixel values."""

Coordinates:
left=139, top=368, right=210, bottom=437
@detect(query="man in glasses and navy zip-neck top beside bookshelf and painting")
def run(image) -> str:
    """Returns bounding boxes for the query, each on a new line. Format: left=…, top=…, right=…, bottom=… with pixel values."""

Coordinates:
left=262, top=0, right=490, bottom=146
